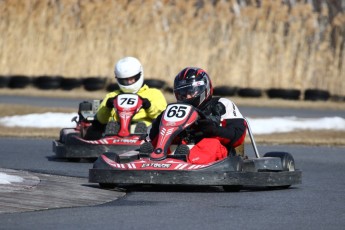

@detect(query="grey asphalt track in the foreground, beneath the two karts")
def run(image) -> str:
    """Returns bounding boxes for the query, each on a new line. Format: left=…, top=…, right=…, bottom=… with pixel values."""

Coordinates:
left=0, top=95, right=345, bottom=230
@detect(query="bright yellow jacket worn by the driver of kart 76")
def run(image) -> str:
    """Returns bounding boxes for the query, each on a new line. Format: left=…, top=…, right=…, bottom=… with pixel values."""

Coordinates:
left=96, top=84, right=167, bottom=126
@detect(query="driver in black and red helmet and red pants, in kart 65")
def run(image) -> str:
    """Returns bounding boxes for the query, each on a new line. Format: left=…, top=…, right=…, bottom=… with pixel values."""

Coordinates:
left=149, top=67, right=247, bottom=164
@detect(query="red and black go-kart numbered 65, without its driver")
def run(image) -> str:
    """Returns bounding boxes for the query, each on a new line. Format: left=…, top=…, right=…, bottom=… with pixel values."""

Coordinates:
left=89, top=103, right=302, bottom=191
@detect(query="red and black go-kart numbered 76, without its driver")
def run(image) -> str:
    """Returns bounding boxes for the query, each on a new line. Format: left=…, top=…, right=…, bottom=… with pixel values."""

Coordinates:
left=53, top=94, right=147, bottom=161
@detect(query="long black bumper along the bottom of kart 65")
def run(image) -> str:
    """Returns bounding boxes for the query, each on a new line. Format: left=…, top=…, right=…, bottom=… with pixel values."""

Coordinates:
left=89, top=169, right=302, bottom=187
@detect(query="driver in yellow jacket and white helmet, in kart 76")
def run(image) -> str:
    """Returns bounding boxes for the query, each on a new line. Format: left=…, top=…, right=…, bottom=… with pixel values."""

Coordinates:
left=85, top=57, right=167, bottom=139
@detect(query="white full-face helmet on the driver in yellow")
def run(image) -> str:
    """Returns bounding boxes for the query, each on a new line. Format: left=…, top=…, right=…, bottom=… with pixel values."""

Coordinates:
left=114, top=57, right=144, bottom=93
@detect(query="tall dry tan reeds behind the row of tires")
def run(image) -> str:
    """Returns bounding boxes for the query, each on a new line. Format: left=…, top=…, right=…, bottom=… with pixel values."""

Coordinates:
left=0, top=0, right=345, bottom=95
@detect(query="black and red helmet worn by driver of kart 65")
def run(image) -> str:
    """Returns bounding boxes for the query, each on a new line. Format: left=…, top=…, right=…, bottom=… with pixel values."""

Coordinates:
left=174, top=67, right=213, bottom=107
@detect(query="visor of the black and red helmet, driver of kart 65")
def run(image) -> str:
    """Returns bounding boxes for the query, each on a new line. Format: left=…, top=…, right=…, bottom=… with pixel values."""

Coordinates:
left=174, top=81, right=206, bottom=101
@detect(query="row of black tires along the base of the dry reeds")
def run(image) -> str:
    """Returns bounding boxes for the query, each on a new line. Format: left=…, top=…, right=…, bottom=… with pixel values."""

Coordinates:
left=0, top=75, right=345, bottom=102
